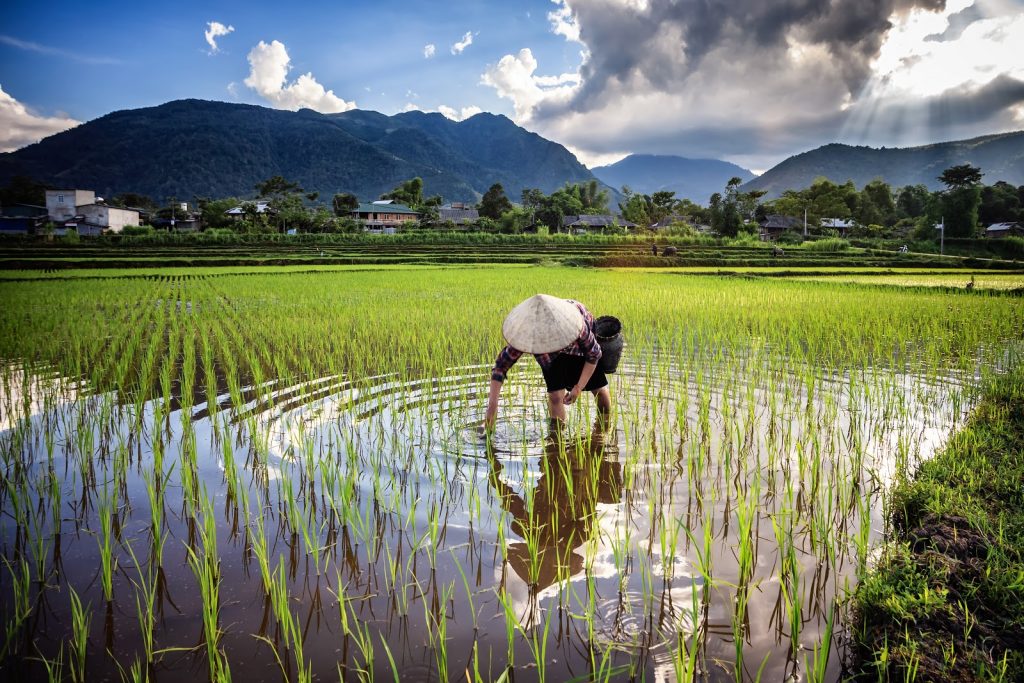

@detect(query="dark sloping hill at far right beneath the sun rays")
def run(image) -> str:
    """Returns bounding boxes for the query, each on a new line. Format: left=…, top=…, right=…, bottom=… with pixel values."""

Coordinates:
left=743, top=131, right=1024, bottom=198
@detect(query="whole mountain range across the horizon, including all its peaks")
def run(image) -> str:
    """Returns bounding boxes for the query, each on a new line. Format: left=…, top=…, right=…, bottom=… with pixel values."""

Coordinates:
left=0, top=99, right=1024, bottom=207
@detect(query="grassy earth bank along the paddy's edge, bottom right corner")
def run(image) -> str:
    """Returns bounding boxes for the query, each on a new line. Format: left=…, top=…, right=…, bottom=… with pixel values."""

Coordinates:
left=853, top=366, right=1024, bottom=681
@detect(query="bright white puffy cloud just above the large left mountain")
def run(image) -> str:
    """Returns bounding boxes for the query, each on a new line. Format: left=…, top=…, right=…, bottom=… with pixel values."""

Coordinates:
left=245, top=40, right=355, bottom=114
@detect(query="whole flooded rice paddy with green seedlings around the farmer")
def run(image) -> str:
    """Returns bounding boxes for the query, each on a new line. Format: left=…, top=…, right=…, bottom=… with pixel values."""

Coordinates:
left=0, top=267, right=1024, bottom=682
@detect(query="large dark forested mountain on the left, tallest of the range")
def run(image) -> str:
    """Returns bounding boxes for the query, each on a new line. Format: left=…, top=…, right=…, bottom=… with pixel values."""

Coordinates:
left=0, top=99, right=594, bottom=201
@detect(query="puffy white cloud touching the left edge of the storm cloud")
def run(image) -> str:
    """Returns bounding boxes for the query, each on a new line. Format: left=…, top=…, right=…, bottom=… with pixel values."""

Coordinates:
left=480, top=47, right=580, bottom=121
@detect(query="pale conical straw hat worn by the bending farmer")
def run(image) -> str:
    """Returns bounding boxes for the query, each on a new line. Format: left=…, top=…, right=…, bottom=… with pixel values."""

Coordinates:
left=502, top=294, right=583, bottom=353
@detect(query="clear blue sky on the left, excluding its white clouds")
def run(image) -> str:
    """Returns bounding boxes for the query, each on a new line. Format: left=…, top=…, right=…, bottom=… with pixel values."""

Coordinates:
left=0, top=0, right=580, bottom=121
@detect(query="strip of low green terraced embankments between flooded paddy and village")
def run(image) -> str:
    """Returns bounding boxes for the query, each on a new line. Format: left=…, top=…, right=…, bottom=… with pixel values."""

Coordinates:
left=0, top=234, right=1024, bottom=271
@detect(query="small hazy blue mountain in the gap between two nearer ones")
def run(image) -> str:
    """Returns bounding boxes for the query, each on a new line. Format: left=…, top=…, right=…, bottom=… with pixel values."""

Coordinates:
left=591, top=155, right=754, bottom=204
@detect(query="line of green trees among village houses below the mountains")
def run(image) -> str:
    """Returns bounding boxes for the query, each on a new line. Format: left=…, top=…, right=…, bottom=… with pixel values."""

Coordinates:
left=0, top=164, right=1024, bottom=239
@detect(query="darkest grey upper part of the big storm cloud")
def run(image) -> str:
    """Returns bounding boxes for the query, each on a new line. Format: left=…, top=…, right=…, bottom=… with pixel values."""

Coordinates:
left=542, top=0, right=945, bottom=116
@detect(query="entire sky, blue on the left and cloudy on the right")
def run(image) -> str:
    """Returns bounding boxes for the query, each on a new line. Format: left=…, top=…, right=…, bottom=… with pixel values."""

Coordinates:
left=0, top=0, right=1024, bottom=172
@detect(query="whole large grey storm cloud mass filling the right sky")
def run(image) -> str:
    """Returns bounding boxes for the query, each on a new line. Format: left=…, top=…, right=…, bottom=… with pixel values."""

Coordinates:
left=505, top=0, right=1024, bottom=169
